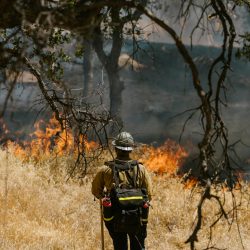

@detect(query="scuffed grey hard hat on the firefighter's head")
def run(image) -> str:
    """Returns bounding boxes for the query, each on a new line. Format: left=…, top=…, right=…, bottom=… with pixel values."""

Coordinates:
left=112, top=132, right=135, bottom=152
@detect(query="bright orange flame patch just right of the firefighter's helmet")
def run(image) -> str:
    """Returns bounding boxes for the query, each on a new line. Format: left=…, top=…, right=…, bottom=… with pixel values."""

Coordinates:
left=142, top=140, right=188, bottom=175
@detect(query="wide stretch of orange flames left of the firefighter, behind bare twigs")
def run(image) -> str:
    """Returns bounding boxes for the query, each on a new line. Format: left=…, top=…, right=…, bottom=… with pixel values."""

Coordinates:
left=5, top=116, right=98, bottom=161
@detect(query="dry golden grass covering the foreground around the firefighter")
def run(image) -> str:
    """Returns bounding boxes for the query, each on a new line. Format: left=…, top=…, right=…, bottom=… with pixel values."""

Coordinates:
left=0, top=151, right=250, bottom=250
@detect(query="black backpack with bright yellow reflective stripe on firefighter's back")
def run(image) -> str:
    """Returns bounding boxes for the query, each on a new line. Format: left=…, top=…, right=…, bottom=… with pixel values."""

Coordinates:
left=107, top=161, right=148, bottom=233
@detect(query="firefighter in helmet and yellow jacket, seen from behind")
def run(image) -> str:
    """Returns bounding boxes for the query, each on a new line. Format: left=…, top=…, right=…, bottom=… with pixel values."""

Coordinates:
left=92, top=132, right=151, bottom=250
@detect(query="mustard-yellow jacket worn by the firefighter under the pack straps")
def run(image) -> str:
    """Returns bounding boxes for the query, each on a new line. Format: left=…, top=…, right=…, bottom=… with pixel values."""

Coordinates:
left=92, top=163, right=152, bottom=200
